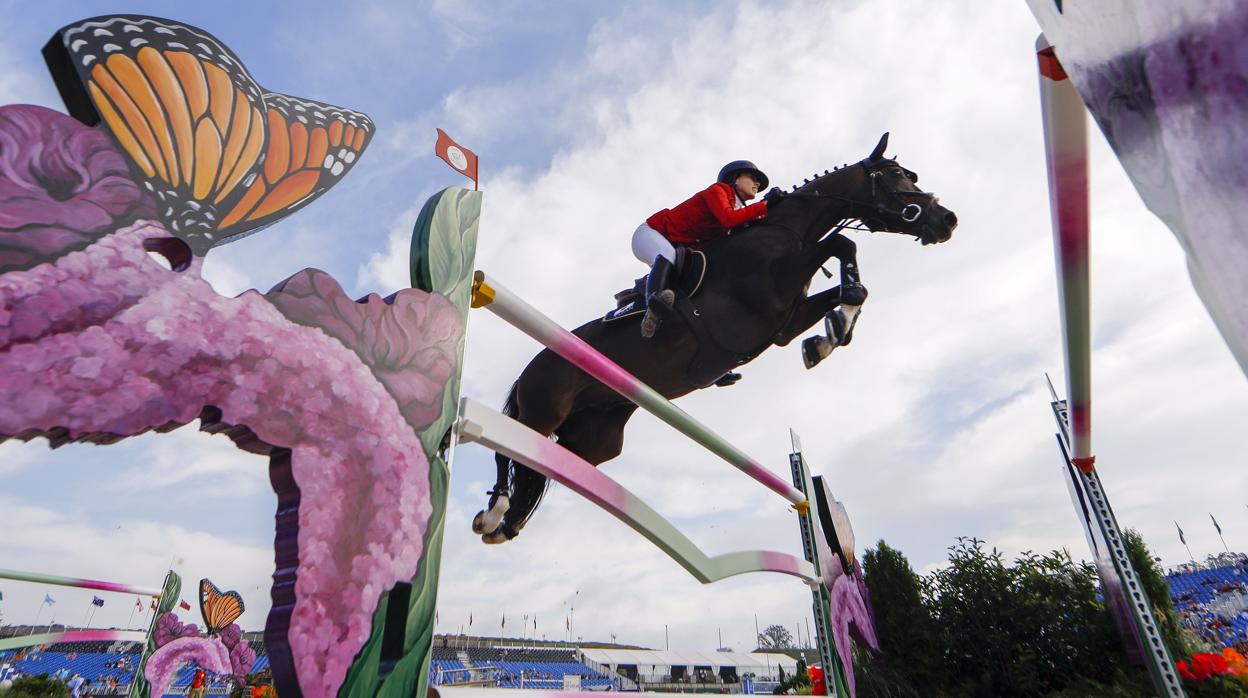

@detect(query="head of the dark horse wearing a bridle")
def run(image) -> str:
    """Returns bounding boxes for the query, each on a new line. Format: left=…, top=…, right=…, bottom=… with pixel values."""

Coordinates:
left=849, top=132, right=957, bottom=245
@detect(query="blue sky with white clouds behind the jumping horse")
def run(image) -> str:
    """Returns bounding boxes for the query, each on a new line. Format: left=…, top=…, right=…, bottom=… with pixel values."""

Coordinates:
left=0, top=0, right=1248, bottom=651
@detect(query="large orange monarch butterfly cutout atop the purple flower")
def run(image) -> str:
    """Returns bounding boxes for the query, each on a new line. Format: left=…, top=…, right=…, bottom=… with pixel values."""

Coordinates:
left=44, top=15, right=376, bottom=255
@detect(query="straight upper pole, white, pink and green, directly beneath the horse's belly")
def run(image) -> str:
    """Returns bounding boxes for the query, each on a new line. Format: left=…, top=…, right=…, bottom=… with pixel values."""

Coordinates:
left=472, top=271, right=810, bottom=513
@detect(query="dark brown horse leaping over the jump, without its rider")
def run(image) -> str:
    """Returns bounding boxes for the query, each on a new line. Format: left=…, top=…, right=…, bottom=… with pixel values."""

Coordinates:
left=473, top=134, right=957, bottom=544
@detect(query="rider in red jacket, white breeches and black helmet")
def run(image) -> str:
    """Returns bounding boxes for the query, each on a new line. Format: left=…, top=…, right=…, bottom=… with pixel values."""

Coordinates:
left=633, top=160, right=784, bottom=344
